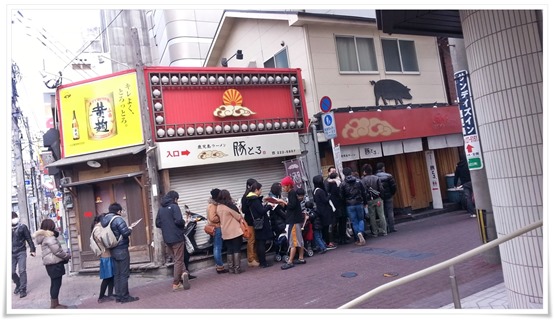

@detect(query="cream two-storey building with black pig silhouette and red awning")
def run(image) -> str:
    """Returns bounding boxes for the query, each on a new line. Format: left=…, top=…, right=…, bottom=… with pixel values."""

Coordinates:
left=206, top=10, right=463, bottom=214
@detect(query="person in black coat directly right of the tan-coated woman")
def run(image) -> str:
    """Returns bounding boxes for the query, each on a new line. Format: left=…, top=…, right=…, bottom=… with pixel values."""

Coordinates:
left=246, top=182, right=274, bottom=268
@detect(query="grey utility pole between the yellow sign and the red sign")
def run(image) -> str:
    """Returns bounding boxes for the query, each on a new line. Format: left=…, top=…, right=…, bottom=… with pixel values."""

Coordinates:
left=131, top=28, right=166, bottom=266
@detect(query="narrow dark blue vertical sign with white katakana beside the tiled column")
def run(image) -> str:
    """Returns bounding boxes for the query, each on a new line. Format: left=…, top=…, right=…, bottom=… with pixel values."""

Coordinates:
left=455, top=70, right=484, bottom=170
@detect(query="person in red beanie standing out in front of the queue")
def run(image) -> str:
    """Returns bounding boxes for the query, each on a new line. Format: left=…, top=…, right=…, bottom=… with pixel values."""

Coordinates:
left=281, top=176, right=306, bottom=270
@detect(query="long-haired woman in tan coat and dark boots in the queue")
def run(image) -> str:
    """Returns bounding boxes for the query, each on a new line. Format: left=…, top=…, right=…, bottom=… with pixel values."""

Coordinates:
left=216, top=189, right=245, bottom=274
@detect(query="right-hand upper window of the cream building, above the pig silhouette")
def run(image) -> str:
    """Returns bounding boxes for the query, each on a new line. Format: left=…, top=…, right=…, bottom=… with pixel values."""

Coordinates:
left=382, top=39, right=419, bottom=72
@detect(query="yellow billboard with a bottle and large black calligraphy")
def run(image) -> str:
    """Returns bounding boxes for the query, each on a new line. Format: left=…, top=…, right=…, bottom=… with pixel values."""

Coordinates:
left=58, top=72, right=143, bottom=157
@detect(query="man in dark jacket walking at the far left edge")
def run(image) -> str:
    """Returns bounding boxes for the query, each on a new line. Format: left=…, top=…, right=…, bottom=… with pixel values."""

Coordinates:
left=12, top=211, right=36, bottom=298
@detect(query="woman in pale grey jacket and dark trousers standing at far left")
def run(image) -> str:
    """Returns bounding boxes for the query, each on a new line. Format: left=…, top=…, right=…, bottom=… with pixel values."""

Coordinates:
left=33, top=219, right=71, bottom=309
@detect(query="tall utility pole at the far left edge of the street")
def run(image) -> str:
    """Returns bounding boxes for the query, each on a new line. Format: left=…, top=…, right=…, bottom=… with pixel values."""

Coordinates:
left=12, top=64, right=29, bottom=226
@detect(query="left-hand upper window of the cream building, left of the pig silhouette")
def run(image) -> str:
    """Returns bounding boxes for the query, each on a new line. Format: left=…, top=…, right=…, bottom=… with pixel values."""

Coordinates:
left=335, top=36, right=378, bottom=72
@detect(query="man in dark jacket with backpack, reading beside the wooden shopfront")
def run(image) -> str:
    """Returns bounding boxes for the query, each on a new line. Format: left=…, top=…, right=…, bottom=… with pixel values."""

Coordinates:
left=100, top=203, right=139, bottom=303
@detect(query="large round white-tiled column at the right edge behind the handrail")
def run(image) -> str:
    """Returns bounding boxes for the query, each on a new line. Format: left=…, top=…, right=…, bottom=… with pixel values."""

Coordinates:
left=461, top=10, right=544, bottom=309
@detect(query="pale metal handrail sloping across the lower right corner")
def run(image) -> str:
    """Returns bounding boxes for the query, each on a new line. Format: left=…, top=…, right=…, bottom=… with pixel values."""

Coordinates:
left=338, top=220, right=543, bottom=309
